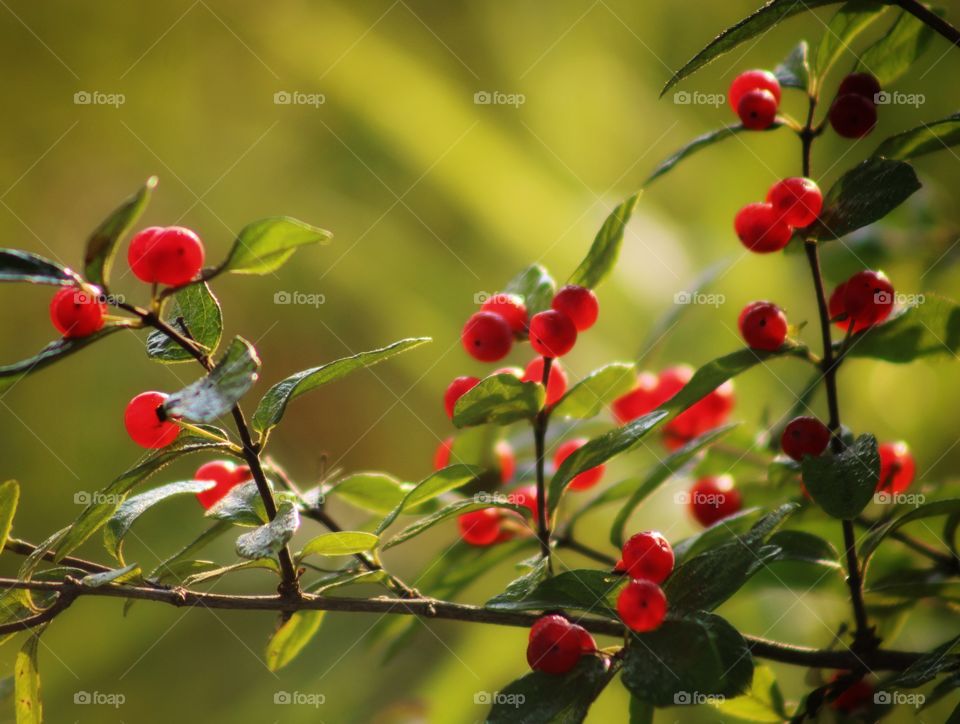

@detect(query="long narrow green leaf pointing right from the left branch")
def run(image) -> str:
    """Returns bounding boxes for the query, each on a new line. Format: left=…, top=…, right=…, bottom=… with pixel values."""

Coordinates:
left=253, top=337, right=430, bottom=433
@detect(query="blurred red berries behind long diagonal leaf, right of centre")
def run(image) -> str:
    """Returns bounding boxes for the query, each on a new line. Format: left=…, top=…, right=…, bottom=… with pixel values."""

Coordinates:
left=612, top=365, right=735, bottom=450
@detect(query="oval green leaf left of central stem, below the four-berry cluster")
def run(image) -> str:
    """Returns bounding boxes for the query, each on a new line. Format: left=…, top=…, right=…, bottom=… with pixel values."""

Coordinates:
left=453, top=373, right=546, bottom=427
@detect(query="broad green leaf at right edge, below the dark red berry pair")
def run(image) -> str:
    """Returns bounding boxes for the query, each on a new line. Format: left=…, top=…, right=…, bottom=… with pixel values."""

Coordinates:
left=847, top=294, right=960, bottom=364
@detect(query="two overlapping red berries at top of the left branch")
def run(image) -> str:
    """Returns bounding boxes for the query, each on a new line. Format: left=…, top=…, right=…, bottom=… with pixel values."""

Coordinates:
left=127, top=226, right=204, bottom=287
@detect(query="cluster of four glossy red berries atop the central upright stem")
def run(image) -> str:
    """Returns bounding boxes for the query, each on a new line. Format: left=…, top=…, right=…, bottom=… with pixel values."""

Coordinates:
left=460, top=284, right=600, bottom=362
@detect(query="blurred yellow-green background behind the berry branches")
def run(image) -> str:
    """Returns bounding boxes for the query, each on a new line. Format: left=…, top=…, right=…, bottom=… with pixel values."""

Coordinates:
left=0, top=0, right=960, bottom=723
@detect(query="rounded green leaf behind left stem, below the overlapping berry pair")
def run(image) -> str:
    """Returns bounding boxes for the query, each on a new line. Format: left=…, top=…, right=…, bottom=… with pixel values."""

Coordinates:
left=147, top=283, right=223, bottom=362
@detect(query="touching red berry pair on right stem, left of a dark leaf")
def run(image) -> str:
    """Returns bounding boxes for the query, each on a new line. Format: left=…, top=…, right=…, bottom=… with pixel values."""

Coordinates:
left=733, top=176, right=823, bottom=254
